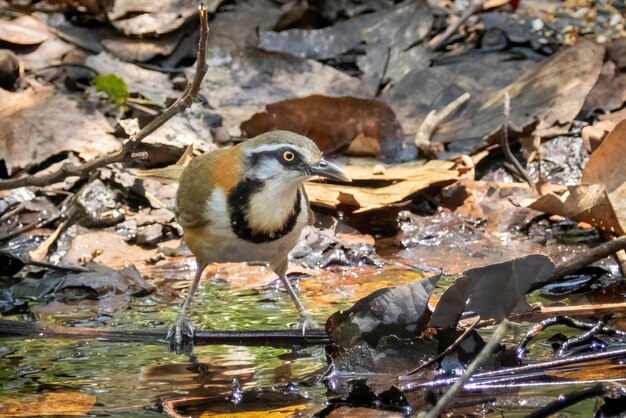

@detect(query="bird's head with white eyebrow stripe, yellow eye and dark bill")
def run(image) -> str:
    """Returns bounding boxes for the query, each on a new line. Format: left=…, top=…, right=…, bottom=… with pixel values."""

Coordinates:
left=240, top=131, right=350, bottom=185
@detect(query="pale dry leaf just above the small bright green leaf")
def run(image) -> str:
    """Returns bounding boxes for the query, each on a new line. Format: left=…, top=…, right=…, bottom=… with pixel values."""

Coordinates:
left=86, top=52, right=179, bottom=107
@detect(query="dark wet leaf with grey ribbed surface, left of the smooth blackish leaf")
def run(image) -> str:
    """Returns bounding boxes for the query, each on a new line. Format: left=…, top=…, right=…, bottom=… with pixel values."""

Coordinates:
left=326, top=275, right=441, bottom=348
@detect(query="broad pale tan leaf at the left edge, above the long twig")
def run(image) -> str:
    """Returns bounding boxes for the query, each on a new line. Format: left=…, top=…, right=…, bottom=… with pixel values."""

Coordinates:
left=0, top=88, right=120, bottom=174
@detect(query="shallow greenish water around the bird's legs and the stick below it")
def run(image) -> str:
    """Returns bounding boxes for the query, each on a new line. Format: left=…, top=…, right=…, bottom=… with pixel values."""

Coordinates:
left=0, top=251, right=620, bottom=417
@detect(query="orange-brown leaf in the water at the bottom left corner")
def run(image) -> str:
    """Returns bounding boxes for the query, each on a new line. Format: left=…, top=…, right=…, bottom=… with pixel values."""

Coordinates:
left=0, top=392, right=96, bottom=417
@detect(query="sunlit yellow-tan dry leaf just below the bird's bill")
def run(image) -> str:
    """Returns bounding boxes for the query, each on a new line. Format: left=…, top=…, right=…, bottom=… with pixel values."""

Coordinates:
left=305, top=168, right=459, bottom=213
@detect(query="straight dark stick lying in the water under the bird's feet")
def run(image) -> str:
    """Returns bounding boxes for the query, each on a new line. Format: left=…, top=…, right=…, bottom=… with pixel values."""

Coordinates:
left=0, top=320, right=330, bottom=347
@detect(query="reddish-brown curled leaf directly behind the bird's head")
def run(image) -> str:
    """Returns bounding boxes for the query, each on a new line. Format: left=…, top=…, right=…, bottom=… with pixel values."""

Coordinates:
left=241, top=95, right=404, bottom=161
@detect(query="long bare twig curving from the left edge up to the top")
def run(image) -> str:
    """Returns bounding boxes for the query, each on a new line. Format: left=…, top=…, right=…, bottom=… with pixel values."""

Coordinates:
left=0, top=3, right=209, bottom=190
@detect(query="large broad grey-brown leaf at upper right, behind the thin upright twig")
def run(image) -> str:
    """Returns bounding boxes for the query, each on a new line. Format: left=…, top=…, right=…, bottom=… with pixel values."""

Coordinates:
left=433, top=41, right=605, bottom=143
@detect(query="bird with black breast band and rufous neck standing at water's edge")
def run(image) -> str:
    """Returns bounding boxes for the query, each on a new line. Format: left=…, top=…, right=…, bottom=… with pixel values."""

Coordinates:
left=166, top=131, right=350, bottom=354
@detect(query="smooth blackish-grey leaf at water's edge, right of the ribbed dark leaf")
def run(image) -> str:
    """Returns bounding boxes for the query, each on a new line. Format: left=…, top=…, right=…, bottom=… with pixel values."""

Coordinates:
left=429, top=254, right=555, bottom=328
